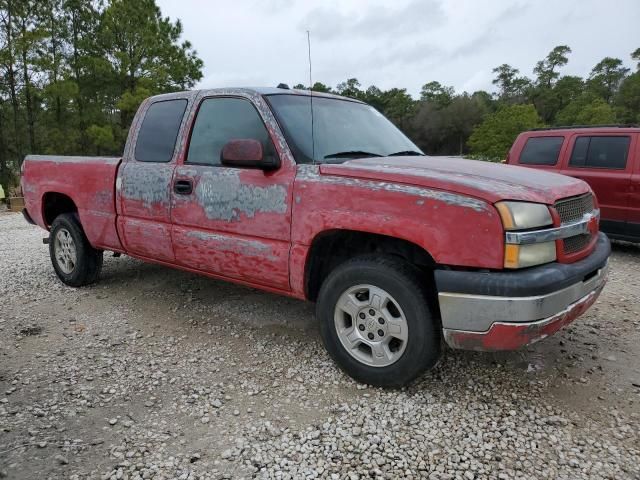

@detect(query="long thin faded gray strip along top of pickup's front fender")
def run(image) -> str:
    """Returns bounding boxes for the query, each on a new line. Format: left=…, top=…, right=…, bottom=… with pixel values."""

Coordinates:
left=296, top=165, right=492, bottom=212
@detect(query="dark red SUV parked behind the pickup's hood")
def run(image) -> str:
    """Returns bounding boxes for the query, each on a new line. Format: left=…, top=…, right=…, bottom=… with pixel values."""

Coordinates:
left=507, top=126, right=640, bottom=242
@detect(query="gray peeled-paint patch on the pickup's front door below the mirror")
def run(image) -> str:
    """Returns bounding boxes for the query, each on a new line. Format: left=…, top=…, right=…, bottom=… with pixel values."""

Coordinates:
left=196, top=169, right=287, bottom=221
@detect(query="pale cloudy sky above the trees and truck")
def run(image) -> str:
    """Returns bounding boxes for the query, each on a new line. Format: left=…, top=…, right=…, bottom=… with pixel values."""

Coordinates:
left=158, top=0, right=640, bottom=95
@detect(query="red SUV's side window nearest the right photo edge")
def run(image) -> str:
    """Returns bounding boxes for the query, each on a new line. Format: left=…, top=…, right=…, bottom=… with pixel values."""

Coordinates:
left=569, top=137, right=631, bottom=170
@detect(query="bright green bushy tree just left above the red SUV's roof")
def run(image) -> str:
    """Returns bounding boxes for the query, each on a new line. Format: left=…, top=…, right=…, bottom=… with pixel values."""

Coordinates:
left=469, top=105, right=544, bottom=161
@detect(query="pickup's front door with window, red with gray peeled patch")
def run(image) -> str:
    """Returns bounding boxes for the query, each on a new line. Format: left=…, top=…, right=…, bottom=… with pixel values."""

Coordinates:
left=171, top=96, right=295, bottom=290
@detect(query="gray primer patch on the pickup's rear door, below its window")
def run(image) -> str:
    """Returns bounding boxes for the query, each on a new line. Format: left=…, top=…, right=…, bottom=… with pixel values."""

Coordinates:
left=121, top=162, right=173, bottom=208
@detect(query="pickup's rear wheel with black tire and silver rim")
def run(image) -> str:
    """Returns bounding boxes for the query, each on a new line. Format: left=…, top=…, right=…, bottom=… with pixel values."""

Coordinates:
left=49, top=213, right=102, bottom=287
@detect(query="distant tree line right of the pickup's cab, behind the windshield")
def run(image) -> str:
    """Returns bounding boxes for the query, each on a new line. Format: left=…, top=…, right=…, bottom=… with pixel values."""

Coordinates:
left=294, top=45, right=640, bottom=161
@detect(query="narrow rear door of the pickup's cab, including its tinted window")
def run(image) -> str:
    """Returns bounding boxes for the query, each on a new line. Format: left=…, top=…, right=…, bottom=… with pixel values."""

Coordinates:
left=116, top=98, right=188, bottom=263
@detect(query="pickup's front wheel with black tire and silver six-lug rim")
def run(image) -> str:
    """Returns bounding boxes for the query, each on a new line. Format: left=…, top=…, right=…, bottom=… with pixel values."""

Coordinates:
left=316, top=255, right=441, bottom=387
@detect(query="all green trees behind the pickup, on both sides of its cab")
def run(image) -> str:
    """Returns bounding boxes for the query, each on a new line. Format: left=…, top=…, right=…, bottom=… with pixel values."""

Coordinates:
left=0, top=0, right=640, bottom=195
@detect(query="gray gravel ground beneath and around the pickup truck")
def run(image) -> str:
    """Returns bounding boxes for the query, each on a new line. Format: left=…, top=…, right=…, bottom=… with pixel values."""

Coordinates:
left=0, top=213, right=640, bottom=480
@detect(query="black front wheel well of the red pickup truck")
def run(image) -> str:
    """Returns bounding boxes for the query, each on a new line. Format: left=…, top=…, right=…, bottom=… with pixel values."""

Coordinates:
left=305, top=230, right=436, bottom=302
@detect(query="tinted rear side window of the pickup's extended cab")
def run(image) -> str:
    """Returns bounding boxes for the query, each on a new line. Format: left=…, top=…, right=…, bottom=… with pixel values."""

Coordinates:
left=135, top=99, right=187, bottom=162
